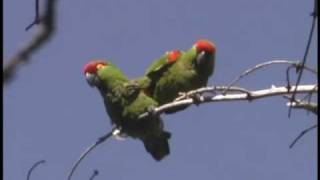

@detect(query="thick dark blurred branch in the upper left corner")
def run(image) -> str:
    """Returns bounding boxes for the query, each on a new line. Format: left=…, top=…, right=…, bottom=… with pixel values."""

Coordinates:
left=3, top=0, right=56, bottom=84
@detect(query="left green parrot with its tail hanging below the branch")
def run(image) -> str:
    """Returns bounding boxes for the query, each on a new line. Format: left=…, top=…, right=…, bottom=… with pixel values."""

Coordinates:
left=84, top=60, right=171, bottom=161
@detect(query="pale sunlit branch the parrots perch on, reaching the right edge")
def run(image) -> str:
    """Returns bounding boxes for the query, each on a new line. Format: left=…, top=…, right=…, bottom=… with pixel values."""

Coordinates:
left=139, top=85, right=318, bottom=118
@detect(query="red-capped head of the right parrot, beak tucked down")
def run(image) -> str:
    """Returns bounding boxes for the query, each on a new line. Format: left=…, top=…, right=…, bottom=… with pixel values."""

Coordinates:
left=193, top=40, right=216, bottom=67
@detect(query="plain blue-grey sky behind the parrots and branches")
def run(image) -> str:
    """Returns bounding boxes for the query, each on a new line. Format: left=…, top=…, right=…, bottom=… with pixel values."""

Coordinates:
left=3, top=0, right=318, bottom=180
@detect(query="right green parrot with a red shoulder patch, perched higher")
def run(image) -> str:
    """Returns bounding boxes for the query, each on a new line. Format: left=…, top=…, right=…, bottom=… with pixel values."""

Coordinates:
left=140, top=40, right=216, bottom=113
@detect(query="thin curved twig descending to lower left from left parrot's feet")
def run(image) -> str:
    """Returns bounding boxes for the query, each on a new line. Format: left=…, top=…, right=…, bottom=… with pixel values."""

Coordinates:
left=68, top=128, right=120, bottom=180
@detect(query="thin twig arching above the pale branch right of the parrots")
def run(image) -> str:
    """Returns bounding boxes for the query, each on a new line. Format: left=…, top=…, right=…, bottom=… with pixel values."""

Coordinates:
left=223, top=60, right=317, bottom=94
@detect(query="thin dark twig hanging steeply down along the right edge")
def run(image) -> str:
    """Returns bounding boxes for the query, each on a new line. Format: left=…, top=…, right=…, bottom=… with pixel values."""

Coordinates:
left=288, top=0, right=318, bottom=117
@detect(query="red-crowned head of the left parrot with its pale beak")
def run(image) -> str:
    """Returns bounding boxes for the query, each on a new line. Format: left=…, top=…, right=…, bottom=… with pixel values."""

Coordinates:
left=83, top=60, right=108, bottom=87
